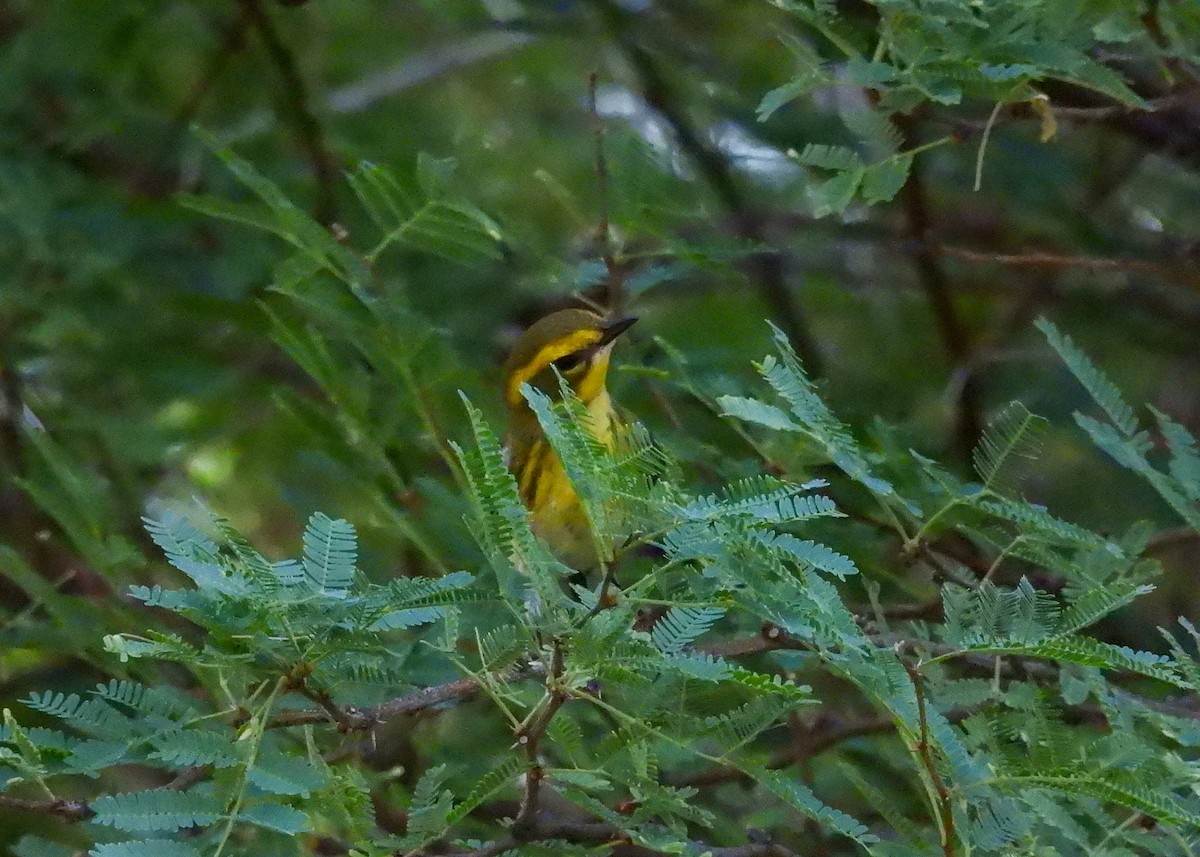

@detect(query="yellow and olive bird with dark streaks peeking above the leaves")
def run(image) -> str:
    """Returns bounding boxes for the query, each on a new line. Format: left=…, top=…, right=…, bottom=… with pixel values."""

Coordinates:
left=504, top=308, right=637, bottom=571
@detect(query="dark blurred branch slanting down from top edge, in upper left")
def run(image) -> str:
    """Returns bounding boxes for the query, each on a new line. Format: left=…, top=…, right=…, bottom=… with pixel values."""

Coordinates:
left=238, top=0, right=337, bottom=226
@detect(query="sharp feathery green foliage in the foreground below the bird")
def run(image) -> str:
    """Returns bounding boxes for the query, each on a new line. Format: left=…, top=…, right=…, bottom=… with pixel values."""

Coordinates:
left=0, top=332, right=1200, bottom=855
